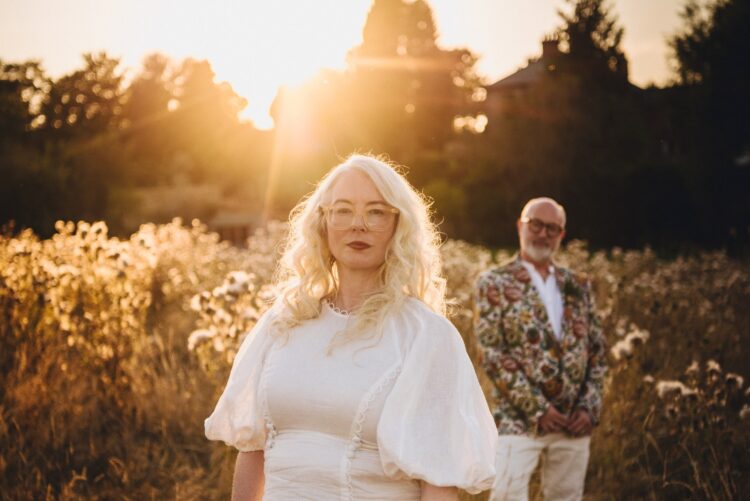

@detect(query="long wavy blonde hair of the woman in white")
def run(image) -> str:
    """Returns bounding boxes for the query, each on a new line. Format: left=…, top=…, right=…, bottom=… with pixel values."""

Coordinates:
left=274, top=155, right=446, bottom=351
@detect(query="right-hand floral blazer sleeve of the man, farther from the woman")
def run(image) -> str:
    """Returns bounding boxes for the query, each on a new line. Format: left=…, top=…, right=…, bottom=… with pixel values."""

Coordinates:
left=576, top=283, right=607, bottom=425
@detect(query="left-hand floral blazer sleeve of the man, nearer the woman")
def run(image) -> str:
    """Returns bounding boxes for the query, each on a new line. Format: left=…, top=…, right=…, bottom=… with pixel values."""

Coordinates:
left=474, top=272, right=550, bottom=431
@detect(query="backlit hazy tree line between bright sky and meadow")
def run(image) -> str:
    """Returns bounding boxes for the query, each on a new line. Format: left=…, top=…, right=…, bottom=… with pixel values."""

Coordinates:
left=0, top=0, right=750, bottom=250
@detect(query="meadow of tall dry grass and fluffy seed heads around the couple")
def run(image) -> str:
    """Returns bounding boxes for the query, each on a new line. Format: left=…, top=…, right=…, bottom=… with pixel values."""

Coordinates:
left=0, top=220, right=750, bottom=500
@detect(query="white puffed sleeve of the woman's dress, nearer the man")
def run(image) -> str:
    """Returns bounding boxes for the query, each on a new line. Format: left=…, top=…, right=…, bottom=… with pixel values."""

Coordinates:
left=378, top=308, right=497, bottom=494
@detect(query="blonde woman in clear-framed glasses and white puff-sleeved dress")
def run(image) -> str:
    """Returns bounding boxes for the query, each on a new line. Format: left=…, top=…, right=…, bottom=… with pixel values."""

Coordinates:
left=206, top=155, right=496, bottom=501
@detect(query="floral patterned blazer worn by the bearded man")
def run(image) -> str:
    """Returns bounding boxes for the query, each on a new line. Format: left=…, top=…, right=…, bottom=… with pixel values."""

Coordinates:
left=474, top=256, right=606, bottom=435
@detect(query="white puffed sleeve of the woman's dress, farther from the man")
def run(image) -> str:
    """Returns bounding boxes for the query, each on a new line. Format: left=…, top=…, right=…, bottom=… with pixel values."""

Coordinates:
left=204, top=310, right=273, bottom=452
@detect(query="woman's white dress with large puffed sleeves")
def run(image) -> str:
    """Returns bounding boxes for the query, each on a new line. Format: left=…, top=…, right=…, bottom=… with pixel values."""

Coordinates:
left=205, top=299, right=497, bottom=501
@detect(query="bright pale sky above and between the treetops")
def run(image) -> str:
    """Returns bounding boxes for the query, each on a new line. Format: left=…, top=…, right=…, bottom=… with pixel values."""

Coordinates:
left=0, top=0, right=685, bottom=128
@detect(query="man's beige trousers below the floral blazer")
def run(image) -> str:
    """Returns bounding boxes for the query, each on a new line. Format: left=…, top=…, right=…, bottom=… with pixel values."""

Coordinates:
left=490, top=433, right=591, bottom=501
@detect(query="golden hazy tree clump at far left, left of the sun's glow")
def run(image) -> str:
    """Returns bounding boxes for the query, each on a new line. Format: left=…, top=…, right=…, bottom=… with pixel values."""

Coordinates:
left=0, top=53, right=270, bottom=236
